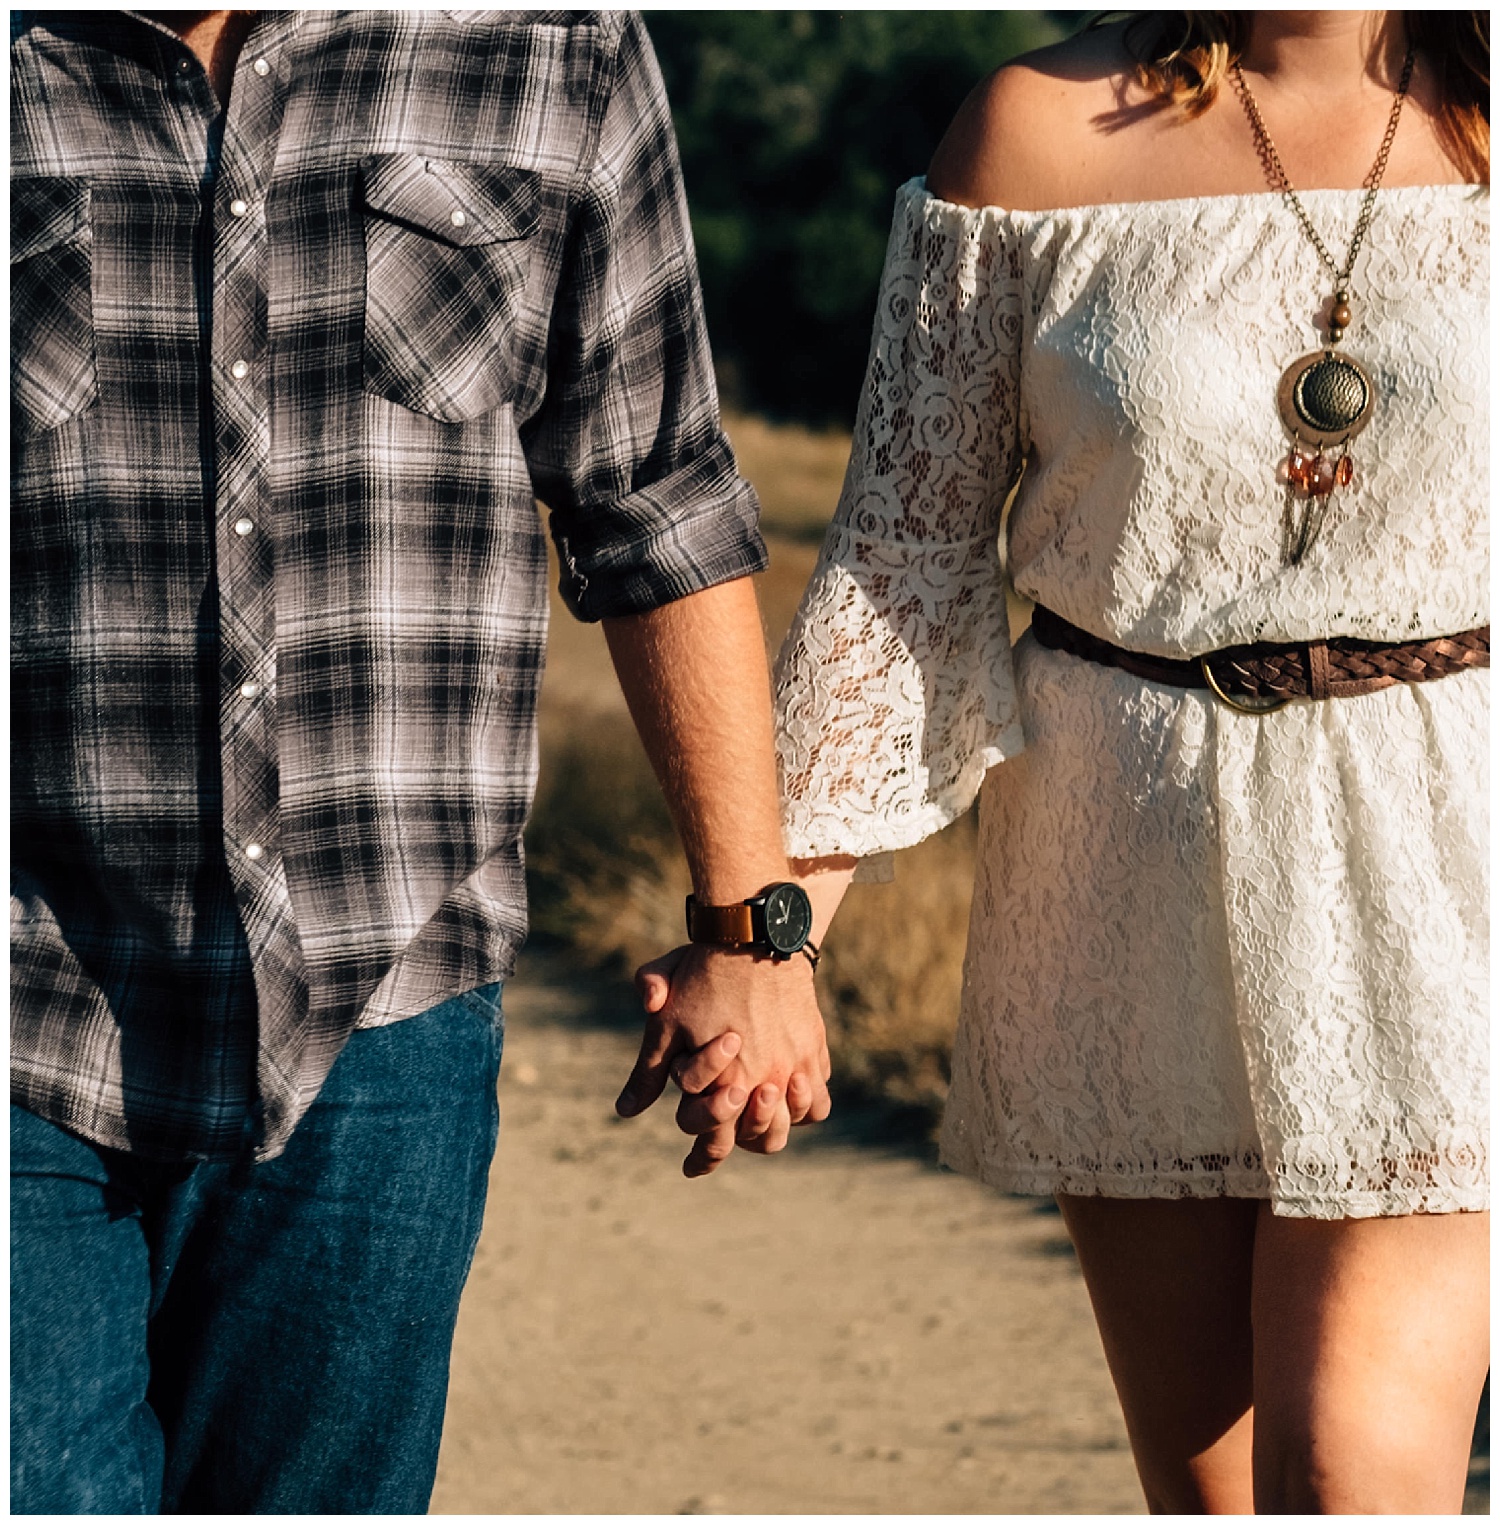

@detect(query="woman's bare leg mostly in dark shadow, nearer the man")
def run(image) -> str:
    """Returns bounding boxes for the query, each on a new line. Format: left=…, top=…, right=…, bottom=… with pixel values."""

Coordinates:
left=1058, top=1196, right=1259, bottom=1514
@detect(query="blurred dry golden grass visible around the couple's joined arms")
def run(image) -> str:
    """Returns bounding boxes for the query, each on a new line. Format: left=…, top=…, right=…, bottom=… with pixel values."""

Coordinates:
left=526, top=416, right=974, bottom=1122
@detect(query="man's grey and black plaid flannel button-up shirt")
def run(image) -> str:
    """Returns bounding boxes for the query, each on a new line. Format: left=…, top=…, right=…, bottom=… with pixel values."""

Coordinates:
left=11, top=11, right=764, bottom=1159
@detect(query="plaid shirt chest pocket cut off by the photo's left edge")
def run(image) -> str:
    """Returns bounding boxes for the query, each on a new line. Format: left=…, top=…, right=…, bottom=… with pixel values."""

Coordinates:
left=11, top=175, right=99, bottom=436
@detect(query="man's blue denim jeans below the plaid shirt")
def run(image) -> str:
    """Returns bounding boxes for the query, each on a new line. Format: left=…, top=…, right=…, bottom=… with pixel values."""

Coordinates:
left=11, top=985, right=503, bottom=1514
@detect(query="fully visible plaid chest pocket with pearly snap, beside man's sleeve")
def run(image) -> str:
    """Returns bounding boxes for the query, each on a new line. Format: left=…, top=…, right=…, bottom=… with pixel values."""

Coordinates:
left=360, top=154, right=538, bottom=422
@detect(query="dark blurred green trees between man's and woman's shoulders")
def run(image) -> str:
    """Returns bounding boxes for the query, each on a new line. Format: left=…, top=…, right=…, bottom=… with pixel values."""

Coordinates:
left=645, top=11, right=1067, bottom=425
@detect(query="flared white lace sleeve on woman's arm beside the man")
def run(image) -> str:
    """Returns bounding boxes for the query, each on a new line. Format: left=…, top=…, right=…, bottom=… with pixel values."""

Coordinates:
left=776, top=181, right=1023, bottom=857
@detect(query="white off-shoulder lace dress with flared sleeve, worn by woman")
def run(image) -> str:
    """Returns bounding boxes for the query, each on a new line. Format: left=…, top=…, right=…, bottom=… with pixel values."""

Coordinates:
left=777, top=181, right=1489, bottom=1218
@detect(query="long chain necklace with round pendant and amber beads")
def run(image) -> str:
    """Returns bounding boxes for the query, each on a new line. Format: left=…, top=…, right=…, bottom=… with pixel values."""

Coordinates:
left=1233, top=47, right=1416, bottom=566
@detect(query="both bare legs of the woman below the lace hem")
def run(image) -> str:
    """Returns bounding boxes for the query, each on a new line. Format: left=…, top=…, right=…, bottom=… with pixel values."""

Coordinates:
left=1058, top=1197, right=1489, bottom=1514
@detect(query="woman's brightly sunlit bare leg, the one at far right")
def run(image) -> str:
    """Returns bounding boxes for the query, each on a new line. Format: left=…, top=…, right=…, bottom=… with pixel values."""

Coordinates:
left=1253, top=1206, right=1489, bottom=1514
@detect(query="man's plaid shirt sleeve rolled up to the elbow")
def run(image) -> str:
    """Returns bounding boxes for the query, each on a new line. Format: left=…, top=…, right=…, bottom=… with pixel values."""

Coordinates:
left=523, top=15, right=765, bottom=621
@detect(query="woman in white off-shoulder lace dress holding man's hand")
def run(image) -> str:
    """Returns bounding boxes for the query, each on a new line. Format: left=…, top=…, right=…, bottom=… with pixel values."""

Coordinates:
left=762, top=11, right=1489, bottom=1513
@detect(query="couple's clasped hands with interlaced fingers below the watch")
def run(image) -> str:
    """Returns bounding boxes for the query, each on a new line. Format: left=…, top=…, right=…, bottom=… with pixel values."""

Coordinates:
left=614, top=942, right=829, bottom=1176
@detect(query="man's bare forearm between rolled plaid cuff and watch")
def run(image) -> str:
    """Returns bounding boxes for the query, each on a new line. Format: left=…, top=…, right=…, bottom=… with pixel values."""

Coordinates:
left=604, top=578, right=790, bottom=904
